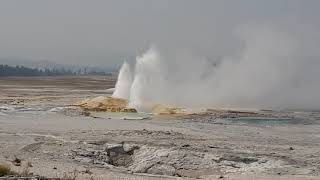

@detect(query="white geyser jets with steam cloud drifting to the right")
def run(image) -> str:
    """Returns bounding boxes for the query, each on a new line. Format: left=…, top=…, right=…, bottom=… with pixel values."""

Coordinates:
left=114, top=26, right=320, bottom=111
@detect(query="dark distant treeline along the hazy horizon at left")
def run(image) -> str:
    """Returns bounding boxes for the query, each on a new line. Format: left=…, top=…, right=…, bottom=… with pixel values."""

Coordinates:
left=0, top=64, right=111, bottom=76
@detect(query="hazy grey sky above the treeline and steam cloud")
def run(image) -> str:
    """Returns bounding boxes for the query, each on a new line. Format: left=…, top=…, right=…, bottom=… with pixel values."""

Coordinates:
left=0, top=0, right=320, bottom=65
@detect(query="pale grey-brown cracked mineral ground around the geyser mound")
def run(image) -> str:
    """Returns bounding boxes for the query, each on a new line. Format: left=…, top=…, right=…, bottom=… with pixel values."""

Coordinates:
left=0, top=76, right=320, bottom=180
